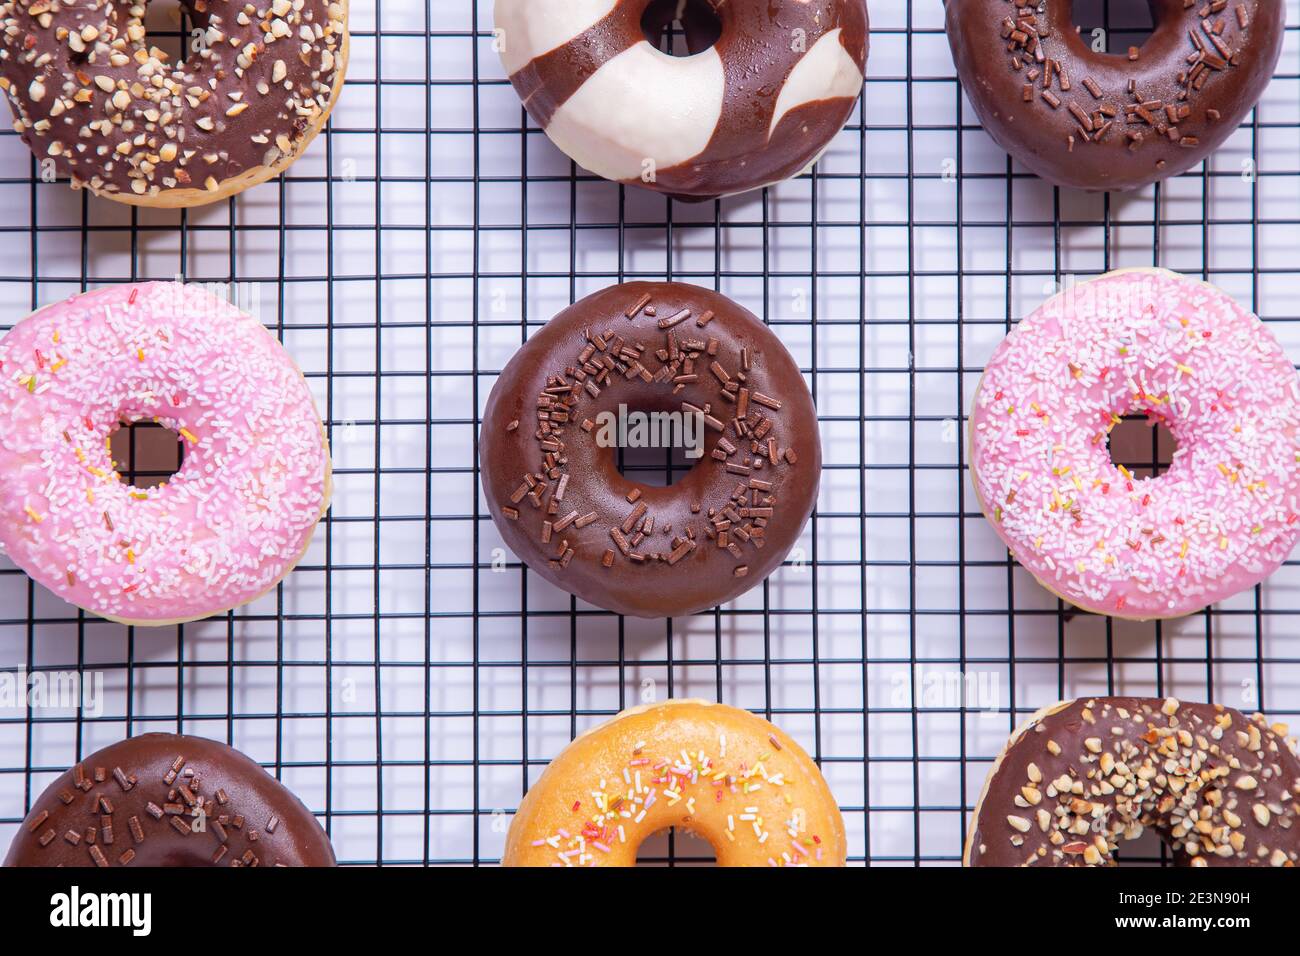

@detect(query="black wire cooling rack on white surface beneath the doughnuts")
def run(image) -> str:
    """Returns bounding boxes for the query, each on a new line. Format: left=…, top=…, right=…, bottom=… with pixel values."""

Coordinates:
left=0, top=0, right=1300, bottom=865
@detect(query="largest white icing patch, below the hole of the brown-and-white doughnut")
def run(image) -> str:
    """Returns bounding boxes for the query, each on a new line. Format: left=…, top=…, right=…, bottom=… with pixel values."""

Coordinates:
left=543, top=43, right=728, bottom=179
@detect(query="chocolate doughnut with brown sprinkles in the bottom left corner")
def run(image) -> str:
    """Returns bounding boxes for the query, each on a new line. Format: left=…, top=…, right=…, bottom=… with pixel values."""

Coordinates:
left=4, top=734, right=334, bottom=866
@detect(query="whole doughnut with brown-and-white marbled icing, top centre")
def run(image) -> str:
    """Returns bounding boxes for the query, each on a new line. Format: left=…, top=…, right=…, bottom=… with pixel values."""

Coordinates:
left=495, top=0, right=867, bottom=200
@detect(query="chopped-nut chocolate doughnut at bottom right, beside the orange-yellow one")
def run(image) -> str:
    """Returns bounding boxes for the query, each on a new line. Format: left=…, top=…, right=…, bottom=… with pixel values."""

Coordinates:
left=963, top=697, right=1300, bottom=866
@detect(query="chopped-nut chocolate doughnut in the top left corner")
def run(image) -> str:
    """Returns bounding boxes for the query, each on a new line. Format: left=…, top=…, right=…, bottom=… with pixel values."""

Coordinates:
left=0, top=0, right=348, bottom=208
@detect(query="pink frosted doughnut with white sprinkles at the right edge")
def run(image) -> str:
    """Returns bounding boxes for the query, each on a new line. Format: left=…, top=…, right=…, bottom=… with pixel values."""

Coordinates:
left=971, top=269, right=1300, bottom=619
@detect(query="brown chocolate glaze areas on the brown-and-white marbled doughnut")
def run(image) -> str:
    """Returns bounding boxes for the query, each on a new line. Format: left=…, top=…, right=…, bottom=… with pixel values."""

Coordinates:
left=510, top=0, right=868, bottom=200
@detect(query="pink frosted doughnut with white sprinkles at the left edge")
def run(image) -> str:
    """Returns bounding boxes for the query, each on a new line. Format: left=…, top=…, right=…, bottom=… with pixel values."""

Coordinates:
left=0, top=282, right=330, bottom=624
